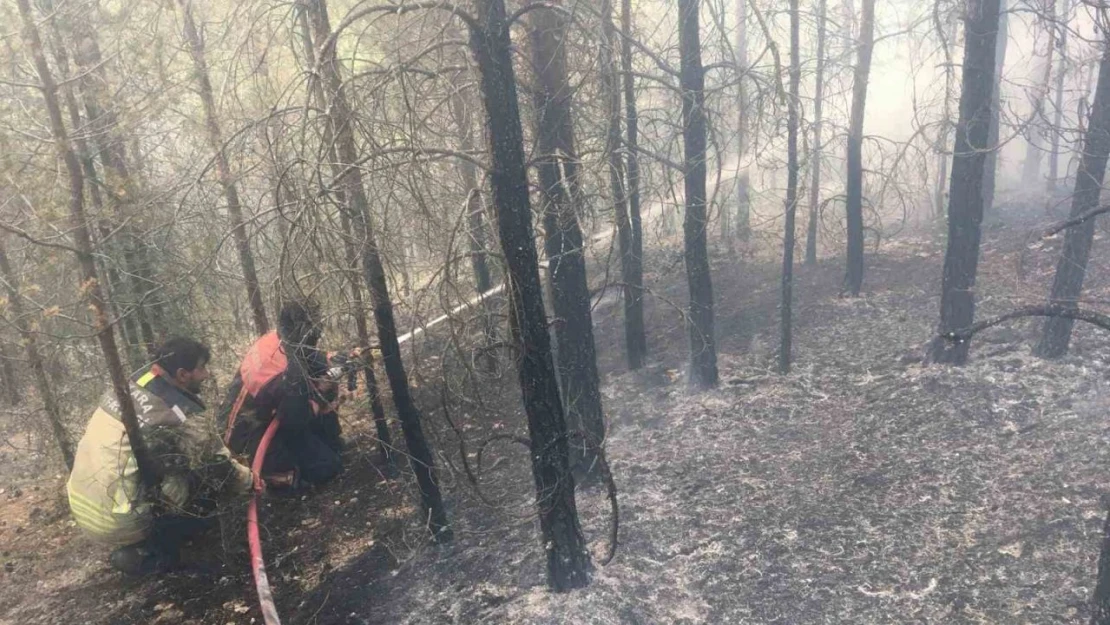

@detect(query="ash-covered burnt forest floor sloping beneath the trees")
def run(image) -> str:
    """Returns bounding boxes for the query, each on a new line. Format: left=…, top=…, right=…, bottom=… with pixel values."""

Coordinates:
left=0, top=217, right=1110, bottom=625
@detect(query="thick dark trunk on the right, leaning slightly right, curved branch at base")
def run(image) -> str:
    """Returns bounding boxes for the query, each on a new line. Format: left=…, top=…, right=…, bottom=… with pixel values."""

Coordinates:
left=929, top=0, right=999, bottom=364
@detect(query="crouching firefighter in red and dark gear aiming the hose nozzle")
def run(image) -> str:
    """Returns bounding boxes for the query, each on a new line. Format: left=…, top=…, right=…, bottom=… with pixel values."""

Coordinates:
left=220, top=301, right=343, bottom=487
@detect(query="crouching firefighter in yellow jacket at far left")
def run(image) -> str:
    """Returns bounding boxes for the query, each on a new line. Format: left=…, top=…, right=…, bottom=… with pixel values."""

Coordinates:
left=67, top=337, right=251, bottom=575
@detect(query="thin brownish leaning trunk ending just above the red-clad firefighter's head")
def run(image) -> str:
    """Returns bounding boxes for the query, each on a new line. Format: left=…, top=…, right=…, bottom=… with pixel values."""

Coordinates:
left=178, top=0, right=270, bottom=336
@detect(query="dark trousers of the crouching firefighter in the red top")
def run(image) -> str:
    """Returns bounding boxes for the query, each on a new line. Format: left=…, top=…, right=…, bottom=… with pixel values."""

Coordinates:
left=262, top=413, right=343, bottom=484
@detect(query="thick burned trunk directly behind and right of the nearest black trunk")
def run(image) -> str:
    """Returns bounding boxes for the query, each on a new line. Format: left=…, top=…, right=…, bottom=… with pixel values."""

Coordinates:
left=531, top=2, right=620, bottom=466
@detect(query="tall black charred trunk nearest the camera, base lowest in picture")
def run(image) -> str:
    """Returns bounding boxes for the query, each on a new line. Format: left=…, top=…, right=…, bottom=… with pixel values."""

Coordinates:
left=471, top=0, right=589, bottom=592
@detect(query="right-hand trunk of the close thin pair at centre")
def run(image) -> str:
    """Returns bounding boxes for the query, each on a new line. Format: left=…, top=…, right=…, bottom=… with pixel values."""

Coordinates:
left=621, top=0, right=647, bottom=371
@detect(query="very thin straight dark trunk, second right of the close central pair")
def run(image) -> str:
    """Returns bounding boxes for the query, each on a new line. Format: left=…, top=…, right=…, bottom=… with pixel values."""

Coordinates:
left=778, top=0, right=801, bottom=374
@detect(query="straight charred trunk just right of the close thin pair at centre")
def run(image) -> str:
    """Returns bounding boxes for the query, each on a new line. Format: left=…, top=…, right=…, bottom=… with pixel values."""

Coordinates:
left=678, top=0, right=717, bottom=389
